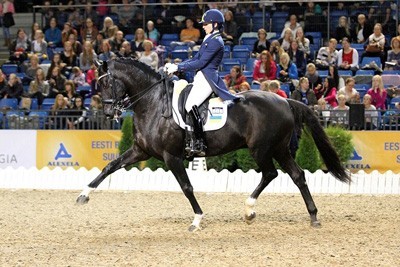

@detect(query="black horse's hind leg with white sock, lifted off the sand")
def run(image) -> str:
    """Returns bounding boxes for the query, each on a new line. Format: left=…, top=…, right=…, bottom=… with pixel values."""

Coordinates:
left=244, top=158, right=278, bottom=224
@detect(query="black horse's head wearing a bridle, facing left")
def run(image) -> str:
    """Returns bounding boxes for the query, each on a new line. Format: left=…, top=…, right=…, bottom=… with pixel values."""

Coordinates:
left=95, top=61, right=126, bottom=118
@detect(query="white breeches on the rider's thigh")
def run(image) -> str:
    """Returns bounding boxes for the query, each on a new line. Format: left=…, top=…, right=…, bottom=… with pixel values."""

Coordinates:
left=185, top=71, right=213, bottom=112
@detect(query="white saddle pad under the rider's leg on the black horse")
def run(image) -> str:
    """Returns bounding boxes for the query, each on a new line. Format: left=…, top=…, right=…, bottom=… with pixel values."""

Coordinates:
left=172, top=80, right=228, bottom=131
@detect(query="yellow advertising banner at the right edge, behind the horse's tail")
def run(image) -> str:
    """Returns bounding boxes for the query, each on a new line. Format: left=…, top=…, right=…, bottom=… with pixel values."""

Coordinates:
left=347, top=131, right=400, bottom=173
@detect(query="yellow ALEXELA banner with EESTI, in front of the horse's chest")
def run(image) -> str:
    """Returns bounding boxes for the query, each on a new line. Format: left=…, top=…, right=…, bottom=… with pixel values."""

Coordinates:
left=36, top=130, right=121, bottom=169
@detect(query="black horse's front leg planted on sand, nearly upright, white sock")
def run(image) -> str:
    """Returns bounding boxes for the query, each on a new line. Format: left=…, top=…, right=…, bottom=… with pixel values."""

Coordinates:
left=164, top=153, right=203, bottom=232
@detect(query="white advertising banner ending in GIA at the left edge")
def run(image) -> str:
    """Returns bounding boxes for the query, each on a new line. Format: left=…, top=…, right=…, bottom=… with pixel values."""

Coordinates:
left=0, top=130, right=36, bottom=169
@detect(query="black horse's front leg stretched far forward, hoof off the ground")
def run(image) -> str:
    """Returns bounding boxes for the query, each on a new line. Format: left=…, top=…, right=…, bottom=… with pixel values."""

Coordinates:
left=76, top=145, right=150, bottom=204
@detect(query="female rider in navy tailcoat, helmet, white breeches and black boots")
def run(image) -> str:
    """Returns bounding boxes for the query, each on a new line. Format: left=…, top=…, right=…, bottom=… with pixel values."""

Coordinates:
left=164, top=9, right=238, bottom=157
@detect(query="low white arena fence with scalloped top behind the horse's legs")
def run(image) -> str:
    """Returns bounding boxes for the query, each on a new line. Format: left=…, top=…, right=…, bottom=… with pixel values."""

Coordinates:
left=0, top=167, right=400, bottom=195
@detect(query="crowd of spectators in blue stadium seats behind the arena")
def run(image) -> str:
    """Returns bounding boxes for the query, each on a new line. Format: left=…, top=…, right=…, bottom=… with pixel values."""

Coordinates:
left=0, top=0, right=400, bottom=128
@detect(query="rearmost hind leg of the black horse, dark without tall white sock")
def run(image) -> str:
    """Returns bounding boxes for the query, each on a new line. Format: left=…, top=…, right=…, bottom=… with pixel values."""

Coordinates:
left=276, top=150, right=321, bottom=227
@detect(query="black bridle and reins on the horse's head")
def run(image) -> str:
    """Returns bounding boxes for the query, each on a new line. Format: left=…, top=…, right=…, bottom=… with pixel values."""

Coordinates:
left=97, top=68, right=168, bottom=120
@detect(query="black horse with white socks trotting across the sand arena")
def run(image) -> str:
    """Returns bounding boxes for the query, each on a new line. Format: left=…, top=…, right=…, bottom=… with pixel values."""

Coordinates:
left=77, top=58, right=350, bottom=231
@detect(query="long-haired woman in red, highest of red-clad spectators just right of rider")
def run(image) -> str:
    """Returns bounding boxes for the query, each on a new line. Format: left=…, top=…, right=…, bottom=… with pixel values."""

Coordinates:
left=253, top=50, right=276, bottom=84
